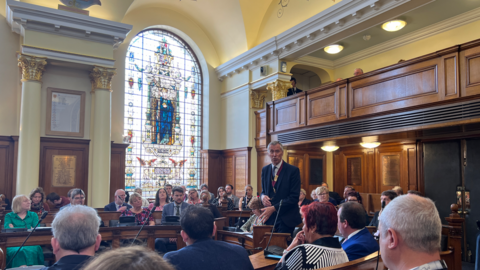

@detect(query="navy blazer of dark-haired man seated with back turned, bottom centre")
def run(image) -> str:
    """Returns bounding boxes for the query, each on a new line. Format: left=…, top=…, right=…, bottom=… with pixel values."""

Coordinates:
left=163, top=238, right=255, bottom=270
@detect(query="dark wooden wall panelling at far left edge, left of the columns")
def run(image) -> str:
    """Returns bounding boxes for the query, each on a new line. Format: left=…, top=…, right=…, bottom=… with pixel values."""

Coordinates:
left=0, top=136, right=16, bottom=202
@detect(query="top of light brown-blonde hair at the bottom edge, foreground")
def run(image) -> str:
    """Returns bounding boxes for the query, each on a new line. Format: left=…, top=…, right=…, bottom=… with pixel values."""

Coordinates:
left=82, top=246, right=175, bottom=270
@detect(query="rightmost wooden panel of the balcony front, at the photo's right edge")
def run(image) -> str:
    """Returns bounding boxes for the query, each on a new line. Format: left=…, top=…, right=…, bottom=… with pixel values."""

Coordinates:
left=460, top=40, right=480, bottom=97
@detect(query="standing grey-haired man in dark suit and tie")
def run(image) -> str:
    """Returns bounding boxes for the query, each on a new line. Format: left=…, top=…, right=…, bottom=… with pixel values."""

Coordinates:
left=260, top=141, right=302, bottom=233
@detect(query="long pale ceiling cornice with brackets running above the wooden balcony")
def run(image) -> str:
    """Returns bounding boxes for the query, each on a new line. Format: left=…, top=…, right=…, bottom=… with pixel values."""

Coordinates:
left=215, top=0, right=435, bottom=81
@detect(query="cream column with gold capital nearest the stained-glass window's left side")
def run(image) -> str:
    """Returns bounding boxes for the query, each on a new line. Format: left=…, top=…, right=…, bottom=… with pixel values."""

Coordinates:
left=88, top=66, right=116, bottom=207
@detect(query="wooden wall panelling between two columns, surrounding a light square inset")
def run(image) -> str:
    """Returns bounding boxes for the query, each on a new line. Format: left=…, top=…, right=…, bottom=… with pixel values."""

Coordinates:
left=39, top=137, right=90, bottom=200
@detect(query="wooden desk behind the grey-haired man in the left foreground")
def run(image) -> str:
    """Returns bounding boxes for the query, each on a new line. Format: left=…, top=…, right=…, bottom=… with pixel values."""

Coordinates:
left=0, top=226, right=186, bottom=269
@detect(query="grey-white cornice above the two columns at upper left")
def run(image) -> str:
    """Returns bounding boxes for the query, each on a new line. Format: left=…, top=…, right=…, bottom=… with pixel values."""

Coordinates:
left=7, top=0, right=132, bottom=48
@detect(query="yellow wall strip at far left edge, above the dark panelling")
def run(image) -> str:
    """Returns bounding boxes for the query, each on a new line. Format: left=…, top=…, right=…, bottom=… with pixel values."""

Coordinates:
left=0, top=0, right=21, bottom=136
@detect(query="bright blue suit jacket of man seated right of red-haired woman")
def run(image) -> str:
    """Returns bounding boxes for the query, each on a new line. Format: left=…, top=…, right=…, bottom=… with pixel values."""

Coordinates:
left=342, top=228, right=379, bottom=261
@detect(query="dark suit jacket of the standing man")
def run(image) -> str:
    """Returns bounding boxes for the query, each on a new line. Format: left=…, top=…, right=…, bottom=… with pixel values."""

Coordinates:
left=262, top=161, right=302, bottom=227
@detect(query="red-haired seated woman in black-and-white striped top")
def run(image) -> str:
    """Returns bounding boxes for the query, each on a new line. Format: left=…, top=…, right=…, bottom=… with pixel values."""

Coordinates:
left=275, top=202, right=348, bottom=270
